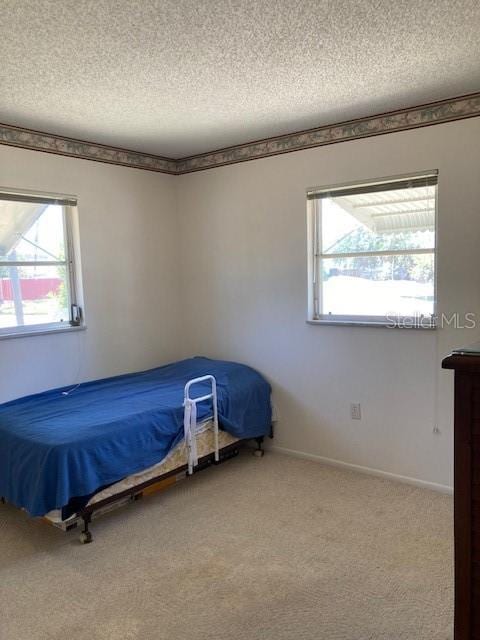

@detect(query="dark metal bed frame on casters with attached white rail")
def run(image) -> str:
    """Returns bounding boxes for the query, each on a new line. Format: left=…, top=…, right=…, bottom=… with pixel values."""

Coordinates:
left=65, top=376, right=273, bottom=544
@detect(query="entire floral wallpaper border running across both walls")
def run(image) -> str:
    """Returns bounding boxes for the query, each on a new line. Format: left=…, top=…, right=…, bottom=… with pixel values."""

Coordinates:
left=0, top=93, right=480, bottom=175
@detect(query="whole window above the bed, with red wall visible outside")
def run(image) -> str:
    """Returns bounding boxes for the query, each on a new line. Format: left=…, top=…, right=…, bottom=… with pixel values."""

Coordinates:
left=0, top=190, right=82, bottom=337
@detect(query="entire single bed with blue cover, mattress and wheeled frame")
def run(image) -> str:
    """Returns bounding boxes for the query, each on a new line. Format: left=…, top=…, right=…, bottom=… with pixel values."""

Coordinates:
left=0, top=357, right=272, bottom=542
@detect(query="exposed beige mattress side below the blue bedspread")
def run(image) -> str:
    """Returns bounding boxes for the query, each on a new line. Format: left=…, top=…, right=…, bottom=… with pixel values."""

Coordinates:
left=45, top=420, right=240, bottom=525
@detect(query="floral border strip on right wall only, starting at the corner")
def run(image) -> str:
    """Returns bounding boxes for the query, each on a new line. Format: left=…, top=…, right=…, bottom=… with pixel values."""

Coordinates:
left=177, top=93, right=480, bottom=174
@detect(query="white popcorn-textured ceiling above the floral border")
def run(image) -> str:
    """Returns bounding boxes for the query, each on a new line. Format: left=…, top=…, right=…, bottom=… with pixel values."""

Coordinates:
left=0, top=0, right=480, bottom=158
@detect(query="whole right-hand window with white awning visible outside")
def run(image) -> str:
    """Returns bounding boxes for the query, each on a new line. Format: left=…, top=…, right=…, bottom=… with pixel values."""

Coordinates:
left=307, top=172, right=437, bottom=328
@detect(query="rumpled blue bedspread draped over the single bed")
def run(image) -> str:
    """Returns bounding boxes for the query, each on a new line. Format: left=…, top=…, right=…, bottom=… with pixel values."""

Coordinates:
left=0, top=358, right=271, bottom=516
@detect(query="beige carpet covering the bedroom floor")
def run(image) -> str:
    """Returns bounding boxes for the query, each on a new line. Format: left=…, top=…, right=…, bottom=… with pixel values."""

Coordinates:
left=0, top=452, right=453, bottom=640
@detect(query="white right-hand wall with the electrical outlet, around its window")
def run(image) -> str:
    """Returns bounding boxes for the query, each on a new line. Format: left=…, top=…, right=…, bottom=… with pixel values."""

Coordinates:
left=176, top=119, right=480, bottom=485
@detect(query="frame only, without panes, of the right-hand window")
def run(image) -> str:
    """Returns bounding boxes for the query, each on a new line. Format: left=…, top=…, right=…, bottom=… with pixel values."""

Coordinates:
left=306, top=169, right=438, bottom=329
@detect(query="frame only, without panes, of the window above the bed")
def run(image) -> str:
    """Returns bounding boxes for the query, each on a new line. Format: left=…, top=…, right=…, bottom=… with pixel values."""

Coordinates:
left=0, top=187, right=86, bottom=340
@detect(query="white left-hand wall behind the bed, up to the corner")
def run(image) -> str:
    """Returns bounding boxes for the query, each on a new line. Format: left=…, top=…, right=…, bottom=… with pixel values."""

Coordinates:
left=0, top=146, right=179, bottom=402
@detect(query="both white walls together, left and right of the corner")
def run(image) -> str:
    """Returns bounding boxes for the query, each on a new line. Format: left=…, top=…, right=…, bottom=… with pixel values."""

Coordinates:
left=0, top=119, right=480, bottom=485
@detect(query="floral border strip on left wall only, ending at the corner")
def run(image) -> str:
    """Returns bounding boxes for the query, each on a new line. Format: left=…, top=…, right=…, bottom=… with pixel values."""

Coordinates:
left=0, top=124, right=177, bottom=173
